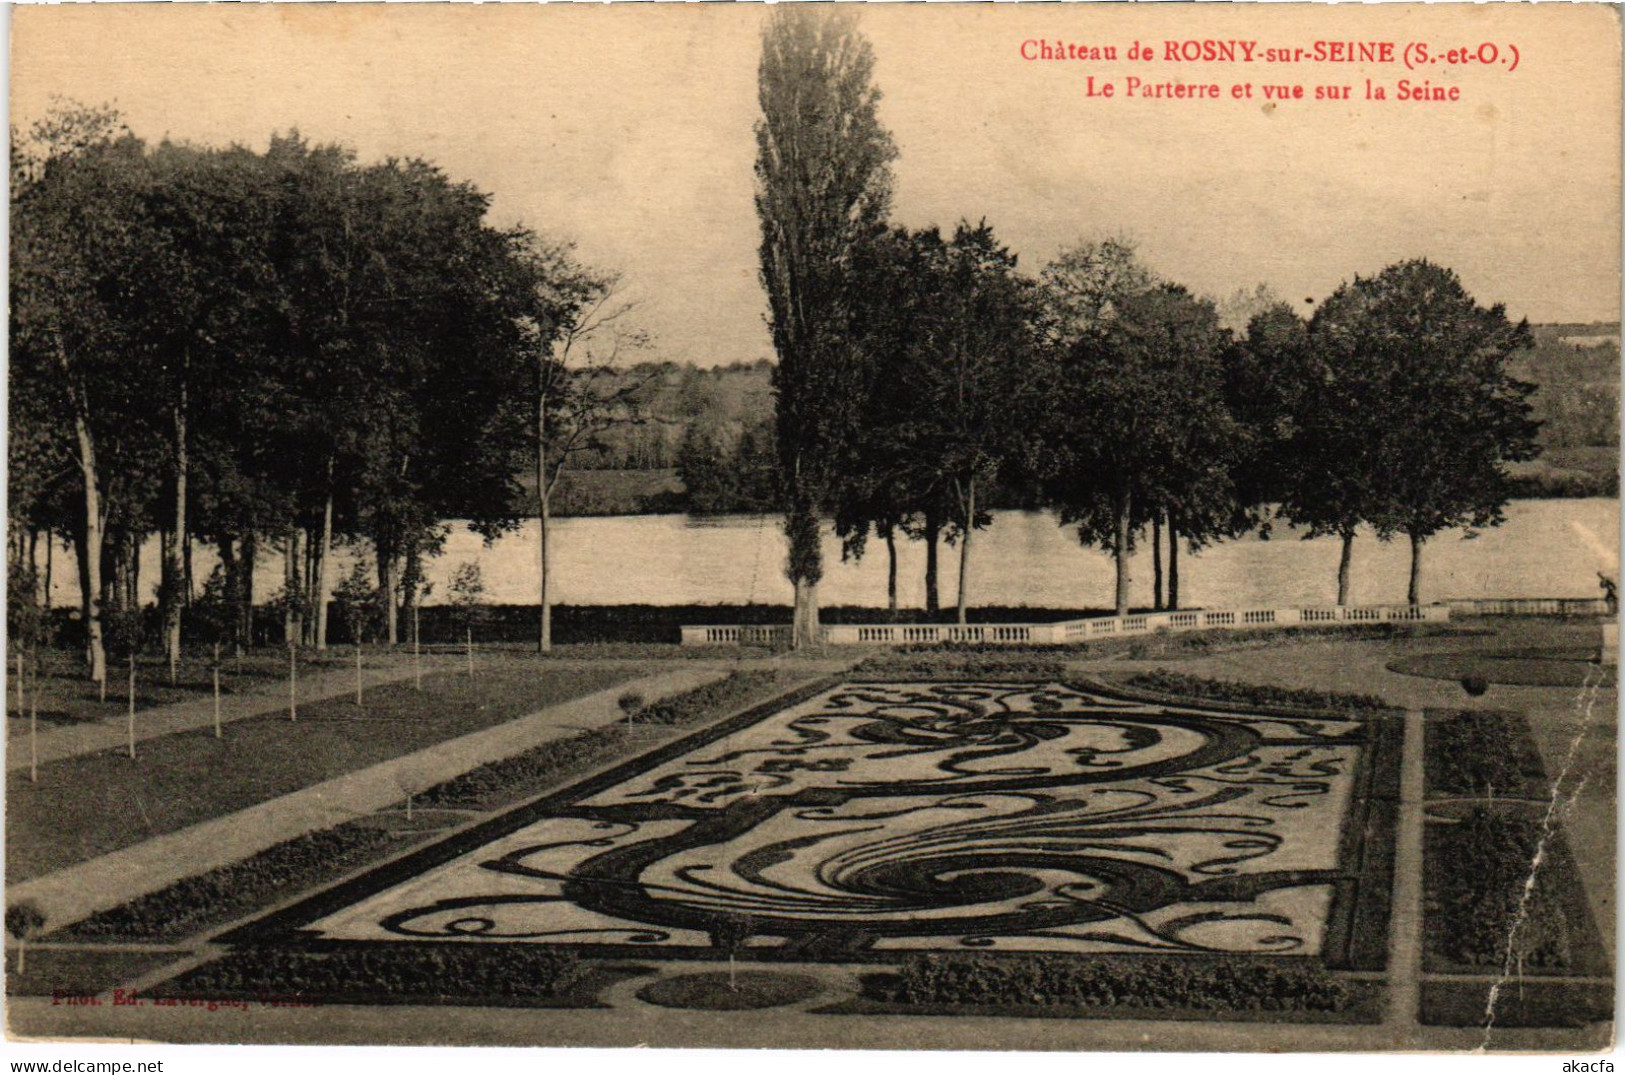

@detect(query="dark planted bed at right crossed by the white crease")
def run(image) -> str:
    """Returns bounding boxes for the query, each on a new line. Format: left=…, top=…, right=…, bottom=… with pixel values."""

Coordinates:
left=1428, top=807, right=1573, bottom=969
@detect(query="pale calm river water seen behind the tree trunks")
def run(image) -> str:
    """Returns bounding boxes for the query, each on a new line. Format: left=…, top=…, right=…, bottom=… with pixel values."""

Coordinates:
left=41, top=499, right=1620, bottom=609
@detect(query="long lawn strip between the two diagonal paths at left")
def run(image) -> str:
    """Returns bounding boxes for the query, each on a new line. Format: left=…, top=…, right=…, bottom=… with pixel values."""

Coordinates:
left=7, top=661, right=637, bottom=883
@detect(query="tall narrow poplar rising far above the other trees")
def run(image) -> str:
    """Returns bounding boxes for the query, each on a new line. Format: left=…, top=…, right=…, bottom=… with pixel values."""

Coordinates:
left=756, top=5, right=895, bottom=646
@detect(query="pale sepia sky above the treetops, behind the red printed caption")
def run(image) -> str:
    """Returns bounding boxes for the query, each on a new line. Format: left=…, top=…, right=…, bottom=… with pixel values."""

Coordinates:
left=11, top=5, right=1620, bottom=365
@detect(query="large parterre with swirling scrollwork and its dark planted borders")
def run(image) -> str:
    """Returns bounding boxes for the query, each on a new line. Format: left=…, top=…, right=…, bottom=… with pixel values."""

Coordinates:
left=149, top=680, right=1399, bottom=1021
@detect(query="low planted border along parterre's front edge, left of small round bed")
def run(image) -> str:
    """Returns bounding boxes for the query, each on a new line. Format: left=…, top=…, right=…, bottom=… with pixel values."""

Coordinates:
left=156, top=943, right=583, bottom=1004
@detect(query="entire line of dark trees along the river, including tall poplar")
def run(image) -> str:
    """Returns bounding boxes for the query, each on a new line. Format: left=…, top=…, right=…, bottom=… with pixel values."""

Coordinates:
left=8, top=8, right=1612, bottom=679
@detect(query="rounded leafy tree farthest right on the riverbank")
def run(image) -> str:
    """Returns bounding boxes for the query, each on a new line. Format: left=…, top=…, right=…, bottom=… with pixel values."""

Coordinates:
left=1311, top=260, right=1539, bottom=604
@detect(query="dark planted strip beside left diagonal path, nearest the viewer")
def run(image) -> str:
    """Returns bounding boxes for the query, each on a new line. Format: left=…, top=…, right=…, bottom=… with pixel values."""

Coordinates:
left=50, top=820, right=392, bottom=940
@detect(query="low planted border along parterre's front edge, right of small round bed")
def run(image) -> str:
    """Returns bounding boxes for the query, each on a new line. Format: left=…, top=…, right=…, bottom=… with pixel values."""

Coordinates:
left=892, top=955, right=1355, bottom=1012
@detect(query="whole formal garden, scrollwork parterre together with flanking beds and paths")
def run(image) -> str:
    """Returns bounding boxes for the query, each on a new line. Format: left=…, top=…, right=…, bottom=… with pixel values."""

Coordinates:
left=10, top=635, right=1612, bottom=1047
